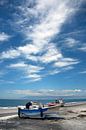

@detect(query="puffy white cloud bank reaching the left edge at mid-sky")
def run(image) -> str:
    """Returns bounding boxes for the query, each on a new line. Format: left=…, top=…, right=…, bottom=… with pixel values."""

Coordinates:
left=0, top=44, right=39, bottom=59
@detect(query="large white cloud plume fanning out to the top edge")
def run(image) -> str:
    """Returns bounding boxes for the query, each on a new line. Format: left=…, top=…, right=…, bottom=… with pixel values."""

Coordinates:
left=16, top=0, right=78, bottom=49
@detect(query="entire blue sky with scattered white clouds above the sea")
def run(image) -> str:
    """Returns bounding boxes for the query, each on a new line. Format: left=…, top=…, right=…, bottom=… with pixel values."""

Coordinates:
left=0, top=0, right=86, bottom=98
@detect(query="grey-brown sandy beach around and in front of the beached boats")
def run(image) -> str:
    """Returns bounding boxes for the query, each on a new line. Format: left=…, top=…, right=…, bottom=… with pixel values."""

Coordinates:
left=0, top=103, right=86, bottom=130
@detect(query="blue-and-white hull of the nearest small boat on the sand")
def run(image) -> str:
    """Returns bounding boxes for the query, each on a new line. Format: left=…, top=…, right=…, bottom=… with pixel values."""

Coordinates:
left=18, top=107, right=48, bottom=118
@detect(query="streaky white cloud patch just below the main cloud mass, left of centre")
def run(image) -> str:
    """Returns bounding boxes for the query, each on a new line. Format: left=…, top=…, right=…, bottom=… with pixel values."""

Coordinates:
left=8, top=62, right=44, bottom=81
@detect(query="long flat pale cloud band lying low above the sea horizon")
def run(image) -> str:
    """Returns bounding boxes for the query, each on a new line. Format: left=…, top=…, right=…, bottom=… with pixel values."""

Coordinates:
left=12, top=89, right=83, bottom=96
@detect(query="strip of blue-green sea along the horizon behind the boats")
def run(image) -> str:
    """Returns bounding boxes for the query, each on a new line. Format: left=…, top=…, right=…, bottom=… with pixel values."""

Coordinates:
left=0, top=97, right=86, bottom=107
